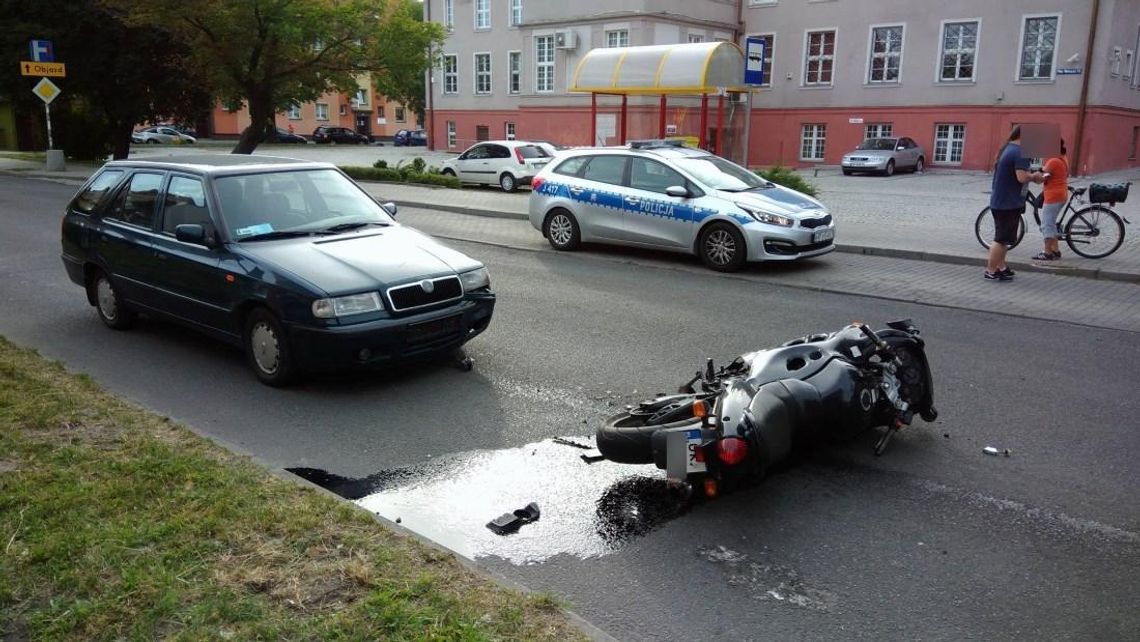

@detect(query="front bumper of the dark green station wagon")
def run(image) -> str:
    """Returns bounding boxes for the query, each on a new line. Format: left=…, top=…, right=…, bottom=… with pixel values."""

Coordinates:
left=288, top=292, right=495, bottom=371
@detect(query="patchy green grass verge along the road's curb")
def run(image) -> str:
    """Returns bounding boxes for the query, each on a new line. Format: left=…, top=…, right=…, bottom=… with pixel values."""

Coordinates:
left=0, top=338, right=583, bottom=641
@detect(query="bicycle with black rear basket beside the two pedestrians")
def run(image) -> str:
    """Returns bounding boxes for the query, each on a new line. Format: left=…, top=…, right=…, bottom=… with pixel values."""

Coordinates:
left=974, top=182, right=1132, bottom=259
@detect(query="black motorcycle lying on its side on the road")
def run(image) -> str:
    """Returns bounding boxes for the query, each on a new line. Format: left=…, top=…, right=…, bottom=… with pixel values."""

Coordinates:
left=595, top=319, right=938, bottom=497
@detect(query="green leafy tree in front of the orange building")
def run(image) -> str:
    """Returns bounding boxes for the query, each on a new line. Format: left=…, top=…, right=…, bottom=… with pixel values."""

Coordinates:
left=111, top=0, right=440, bottom=154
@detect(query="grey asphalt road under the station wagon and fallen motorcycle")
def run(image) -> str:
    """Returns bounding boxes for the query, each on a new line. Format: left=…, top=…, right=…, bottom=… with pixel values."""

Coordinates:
left=0, top=177, right=1140, bottom=640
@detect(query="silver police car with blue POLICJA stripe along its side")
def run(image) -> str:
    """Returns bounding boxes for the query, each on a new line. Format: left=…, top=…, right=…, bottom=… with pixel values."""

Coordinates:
left=530, top=141, right=836, bottom=271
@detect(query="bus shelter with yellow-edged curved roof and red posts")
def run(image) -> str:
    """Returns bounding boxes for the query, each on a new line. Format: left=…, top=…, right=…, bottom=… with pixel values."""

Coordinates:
left=569, top=41, right=749, bottom=156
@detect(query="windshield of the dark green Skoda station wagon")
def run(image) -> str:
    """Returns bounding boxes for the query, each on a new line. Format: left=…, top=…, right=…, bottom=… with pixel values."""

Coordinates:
left=214, top=169, right=392, bottom=241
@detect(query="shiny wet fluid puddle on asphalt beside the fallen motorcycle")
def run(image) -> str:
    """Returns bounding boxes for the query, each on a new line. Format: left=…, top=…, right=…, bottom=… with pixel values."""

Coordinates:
left=286, top=437, right=689, bottom=564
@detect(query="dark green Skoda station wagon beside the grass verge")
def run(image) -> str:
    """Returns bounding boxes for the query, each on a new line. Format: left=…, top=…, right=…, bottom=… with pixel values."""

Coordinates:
left=63, top=154, right=495, bottom=385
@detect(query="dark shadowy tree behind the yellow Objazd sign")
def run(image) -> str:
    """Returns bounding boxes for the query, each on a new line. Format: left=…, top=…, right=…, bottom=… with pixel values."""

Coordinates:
left=0, top=0, right=212, bottom=159
